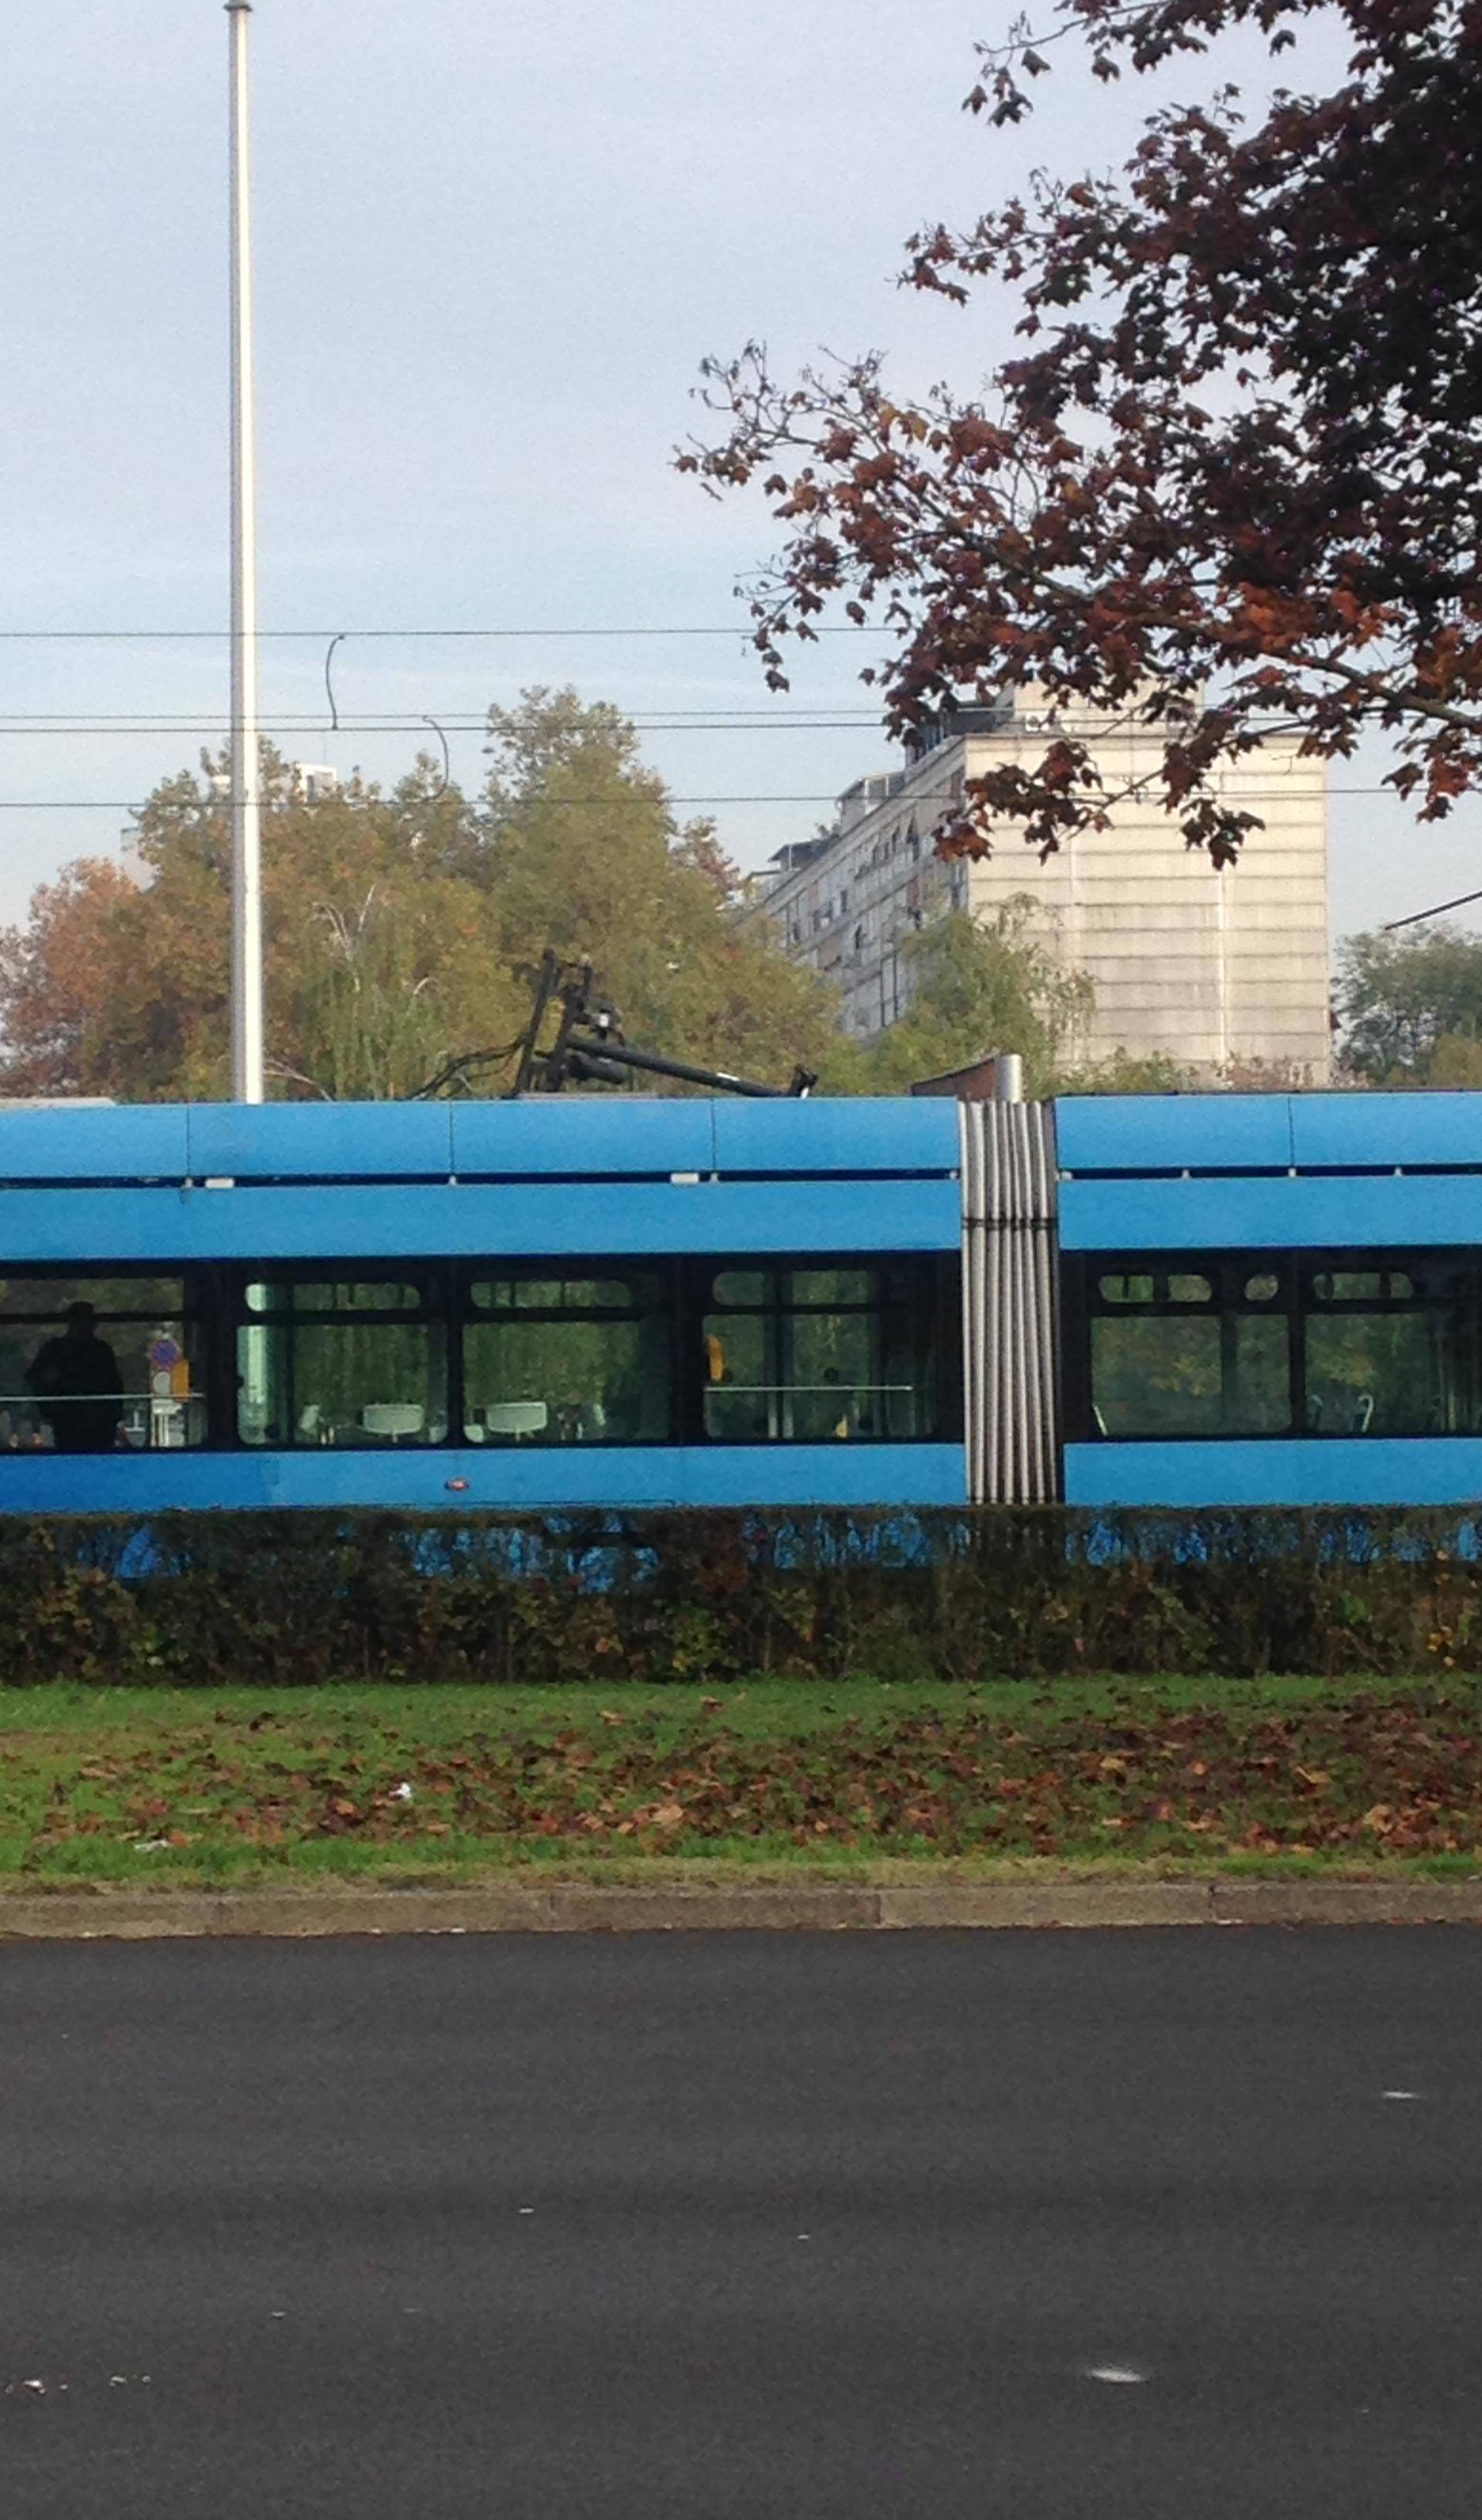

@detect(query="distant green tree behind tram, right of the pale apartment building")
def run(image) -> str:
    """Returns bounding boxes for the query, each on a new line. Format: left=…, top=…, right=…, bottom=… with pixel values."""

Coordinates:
left=1338, top=925, right=1482, bottom=1086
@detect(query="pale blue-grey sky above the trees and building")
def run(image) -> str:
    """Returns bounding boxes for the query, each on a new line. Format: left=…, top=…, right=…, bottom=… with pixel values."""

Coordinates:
left=0, top=0, right=1482, bottom=930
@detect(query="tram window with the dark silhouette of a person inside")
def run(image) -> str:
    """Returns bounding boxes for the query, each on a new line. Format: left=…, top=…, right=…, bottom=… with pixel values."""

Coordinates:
left=0, top=1275, right=207, bottom=1451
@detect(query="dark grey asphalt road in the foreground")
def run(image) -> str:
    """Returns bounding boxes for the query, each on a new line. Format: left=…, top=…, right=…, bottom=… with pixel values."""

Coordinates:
left=0, top=1928, right=1482, bottom=2520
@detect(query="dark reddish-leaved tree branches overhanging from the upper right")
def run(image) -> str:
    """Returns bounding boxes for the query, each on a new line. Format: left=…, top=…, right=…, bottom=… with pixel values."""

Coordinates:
left=681, top=0, right=1482, bottom=862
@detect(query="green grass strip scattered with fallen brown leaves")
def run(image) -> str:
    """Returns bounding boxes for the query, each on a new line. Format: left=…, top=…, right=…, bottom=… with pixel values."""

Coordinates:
left=0, top=1676, right=1482, bottom=1888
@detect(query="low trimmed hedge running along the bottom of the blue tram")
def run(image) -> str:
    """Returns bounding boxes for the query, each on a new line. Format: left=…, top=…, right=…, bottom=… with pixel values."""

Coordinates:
left=0, top=1507, right=1482, bottom=1688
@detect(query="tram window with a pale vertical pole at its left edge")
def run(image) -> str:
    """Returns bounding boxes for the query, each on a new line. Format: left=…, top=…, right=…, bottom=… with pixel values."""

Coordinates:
left=237, top=1275, right=448, bottom=1449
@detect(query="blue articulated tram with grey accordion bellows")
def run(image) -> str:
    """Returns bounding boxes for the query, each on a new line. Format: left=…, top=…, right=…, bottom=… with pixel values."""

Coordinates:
left=0, top=1094, right=1482, bottom=1512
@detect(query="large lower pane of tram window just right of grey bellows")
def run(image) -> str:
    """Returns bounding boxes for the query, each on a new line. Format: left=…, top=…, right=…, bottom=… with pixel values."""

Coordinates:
left=1091, top=1313, right=1291, bottom=1436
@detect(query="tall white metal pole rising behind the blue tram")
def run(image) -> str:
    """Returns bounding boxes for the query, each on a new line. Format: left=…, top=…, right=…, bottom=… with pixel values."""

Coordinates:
left=227, top=0, right=262, bottom=1104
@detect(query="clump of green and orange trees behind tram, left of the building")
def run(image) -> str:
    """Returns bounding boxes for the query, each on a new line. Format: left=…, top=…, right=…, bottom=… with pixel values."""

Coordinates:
left=0, top=690, right=839, bottom=1101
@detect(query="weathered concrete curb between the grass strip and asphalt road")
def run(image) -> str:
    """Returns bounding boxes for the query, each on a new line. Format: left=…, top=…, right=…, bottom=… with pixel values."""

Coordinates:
left=0, top=1878, right=1482, bottom=1943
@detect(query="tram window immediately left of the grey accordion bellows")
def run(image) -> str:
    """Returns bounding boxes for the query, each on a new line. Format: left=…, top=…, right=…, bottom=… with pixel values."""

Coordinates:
left=703, top=1262, right=938, bottom=1444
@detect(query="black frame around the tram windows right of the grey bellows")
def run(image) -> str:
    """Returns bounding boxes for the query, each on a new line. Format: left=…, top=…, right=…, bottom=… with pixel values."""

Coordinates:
left=1061, top=1245, right=1482, bottom=1444
